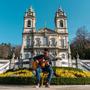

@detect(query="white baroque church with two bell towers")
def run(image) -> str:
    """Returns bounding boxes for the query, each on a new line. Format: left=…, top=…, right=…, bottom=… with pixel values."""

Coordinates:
left=21, top=7, right=70, bottom=66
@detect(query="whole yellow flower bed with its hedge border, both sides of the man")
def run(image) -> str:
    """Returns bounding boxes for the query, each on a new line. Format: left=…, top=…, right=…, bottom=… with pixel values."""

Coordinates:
left=0, top=67, right=90, bottom=85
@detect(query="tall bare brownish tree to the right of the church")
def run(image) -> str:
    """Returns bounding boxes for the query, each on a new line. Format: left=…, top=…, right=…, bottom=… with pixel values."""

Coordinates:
left=71, top=27, right=90, bottom=59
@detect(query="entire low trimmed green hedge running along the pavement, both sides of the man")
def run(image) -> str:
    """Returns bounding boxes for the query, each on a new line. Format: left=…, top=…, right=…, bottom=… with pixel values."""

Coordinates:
left=0, top=77, right=90, bottom=85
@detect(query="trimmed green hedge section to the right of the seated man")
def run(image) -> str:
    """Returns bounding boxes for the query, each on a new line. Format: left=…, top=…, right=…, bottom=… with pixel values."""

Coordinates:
left=51, top=77, right=90, bottom=85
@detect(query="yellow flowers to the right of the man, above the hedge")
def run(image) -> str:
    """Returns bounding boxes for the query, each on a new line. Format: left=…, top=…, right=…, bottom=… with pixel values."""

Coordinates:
left=55, top=68, right=90, bottom=78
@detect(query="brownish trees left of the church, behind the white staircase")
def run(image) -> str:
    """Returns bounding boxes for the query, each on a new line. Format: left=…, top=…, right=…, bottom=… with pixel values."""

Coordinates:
left=0, top=43, right=21, bottom=59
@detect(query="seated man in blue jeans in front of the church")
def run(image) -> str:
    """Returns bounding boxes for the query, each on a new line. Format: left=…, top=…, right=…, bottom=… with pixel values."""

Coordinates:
left=34, top=49, right=53, bottom=88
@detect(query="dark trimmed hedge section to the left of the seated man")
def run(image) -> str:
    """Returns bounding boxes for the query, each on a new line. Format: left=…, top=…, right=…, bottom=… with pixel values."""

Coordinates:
left=0, top=77, right=36, bottom=85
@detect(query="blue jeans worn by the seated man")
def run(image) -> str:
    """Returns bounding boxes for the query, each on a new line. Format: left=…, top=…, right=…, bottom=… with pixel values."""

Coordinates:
left=36, top=66, right=53, bottom=83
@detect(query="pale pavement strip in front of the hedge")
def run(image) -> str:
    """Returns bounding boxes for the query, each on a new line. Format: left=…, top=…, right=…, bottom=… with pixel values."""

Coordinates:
left=0, top=85, right=90, bottom=90
